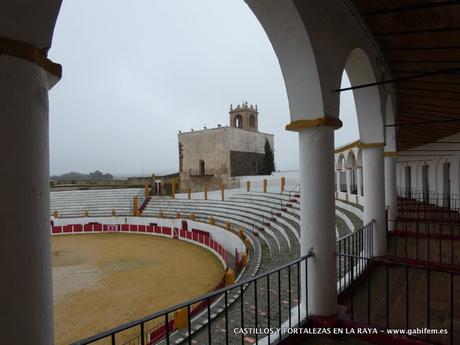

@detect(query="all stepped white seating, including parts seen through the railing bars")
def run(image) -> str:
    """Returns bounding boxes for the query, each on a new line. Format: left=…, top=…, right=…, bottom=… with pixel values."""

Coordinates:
left=51, top=189, right=366, bottom=343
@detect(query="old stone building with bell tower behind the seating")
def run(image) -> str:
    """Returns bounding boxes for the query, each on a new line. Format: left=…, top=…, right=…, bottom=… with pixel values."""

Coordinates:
left=178, top=102, right=274, bottom=191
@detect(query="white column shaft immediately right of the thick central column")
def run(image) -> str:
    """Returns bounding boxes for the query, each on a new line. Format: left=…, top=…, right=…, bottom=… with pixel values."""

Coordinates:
left=363, top=146, right=387, bottom=256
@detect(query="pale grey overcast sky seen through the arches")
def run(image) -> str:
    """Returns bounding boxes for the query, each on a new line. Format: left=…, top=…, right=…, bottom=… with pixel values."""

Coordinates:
left=49, top=0, right=358, bottom=176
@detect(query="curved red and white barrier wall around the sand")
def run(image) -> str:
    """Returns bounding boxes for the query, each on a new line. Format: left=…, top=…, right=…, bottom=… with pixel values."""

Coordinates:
left=51, top=217, right=246, bottom=268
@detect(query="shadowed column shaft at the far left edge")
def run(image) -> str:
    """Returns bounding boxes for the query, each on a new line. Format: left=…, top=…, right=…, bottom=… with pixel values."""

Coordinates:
left=0, top=55, right=54, bottom=344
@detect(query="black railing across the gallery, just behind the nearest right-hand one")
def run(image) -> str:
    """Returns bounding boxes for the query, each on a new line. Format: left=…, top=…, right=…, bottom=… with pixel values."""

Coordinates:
left=387, top=219, right=460, bottom=265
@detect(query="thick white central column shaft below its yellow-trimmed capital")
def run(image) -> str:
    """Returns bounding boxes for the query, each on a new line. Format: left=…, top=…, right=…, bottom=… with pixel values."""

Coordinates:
left=299, top=127, right=337, bottom=316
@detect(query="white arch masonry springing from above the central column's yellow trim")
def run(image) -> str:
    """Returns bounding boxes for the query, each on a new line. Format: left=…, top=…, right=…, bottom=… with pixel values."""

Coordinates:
left=245, top=0, right=389, bottom=132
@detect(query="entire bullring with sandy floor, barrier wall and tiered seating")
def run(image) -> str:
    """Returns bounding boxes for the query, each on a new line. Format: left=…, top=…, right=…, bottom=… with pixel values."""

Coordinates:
left=50, top=173, right=363, bottom=344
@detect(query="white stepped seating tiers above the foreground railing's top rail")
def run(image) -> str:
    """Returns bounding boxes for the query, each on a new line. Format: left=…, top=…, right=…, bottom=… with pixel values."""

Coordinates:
left=50, top=189, right=360, bottom=267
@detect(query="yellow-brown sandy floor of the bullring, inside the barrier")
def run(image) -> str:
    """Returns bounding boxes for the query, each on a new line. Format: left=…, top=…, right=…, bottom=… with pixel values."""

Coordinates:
left=52, top=234, right=224, bottom=345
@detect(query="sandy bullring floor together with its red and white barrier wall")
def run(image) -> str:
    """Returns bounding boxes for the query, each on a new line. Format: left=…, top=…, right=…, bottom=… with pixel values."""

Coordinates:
left=51, top=207, right=247, bottom=344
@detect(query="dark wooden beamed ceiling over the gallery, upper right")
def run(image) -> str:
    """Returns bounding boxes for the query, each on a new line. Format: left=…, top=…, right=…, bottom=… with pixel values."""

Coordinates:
left=352, top=0, right=460, bottom=150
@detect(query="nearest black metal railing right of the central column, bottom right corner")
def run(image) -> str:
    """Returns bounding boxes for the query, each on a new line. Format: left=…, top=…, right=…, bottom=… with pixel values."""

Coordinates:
left=337, top=253, right=460, bottom=344
